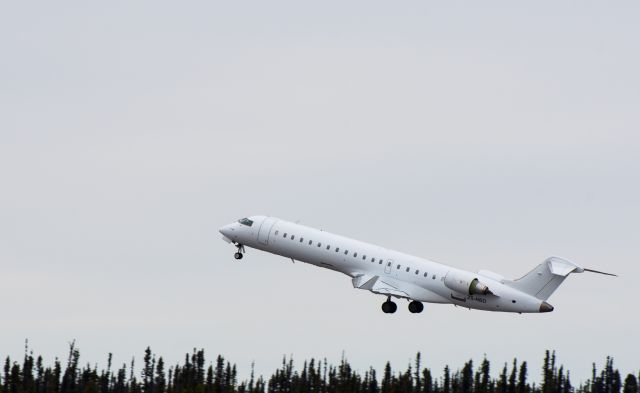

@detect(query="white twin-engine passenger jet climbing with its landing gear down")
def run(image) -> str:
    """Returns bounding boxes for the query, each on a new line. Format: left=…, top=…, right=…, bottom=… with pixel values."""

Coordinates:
left=220, top=216, right=615, bottom=313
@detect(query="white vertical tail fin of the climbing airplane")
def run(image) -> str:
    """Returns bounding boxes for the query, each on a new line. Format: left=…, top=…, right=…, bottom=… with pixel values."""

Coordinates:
left=505, top=257, right=585, bottom=300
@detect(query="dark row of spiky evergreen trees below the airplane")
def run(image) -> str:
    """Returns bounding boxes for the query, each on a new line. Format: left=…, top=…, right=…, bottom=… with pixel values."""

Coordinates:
left=0, top=343, right=640, bottom=393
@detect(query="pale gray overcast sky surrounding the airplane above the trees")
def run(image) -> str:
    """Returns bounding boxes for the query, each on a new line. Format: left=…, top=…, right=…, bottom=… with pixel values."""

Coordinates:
left=0, top=1, right=640, bottom=380
